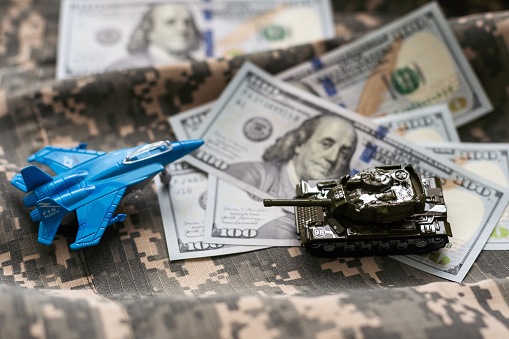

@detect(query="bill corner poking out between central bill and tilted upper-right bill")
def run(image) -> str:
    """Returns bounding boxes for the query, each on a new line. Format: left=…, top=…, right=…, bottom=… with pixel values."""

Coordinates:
left=373, top=104, right=460, bottom=142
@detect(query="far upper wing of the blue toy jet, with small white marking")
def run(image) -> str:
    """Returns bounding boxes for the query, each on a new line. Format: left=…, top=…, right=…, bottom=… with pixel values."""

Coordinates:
left=28, top=144, right=106, bottom=174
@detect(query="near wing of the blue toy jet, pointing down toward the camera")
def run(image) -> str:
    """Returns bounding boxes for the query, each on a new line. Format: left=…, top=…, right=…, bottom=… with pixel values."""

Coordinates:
left=71, top=187, right=126, bottom=250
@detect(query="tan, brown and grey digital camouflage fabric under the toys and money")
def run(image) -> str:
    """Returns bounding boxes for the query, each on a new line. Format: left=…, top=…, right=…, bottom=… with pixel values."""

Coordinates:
left=0, top=0, right=509, bottom=338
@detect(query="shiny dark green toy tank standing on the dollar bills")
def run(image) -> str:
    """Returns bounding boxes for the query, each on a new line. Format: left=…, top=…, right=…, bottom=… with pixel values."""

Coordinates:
left=263, top=165, right=452, bottom=256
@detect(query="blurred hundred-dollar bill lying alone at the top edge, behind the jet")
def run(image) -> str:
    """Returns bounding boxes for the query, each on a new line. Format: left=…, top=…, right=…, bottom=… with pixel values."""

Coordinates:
left=57, top=0, right=334, bottom=79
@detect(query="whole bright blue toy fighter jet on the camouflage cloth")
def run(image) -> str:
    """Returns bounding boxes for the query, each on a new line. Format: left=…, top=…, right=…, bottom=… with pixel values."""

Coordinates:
left=11, top=140, right=203, bottom=250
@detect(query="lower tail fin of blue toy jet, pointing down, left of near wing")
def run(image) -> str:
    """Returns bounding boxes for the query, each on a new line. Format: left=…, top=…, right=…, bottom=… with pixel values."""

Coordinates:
left=37, top=198, right=70, bottom=245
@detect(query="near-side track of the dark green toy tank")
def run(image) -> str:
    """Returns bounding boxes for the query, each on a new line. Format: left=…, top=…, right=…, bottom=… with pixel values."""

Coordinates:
left=304, top=235, right=449, bottom=257
